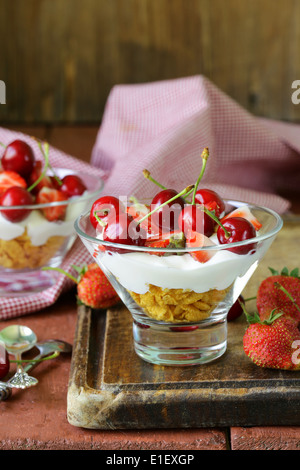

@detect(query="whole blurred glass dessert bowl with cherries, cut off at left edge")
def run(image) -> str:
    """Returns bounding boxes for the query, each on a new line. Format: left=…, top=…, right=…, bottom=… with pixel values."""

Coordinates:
left=0, top=139, right=103, bottom=296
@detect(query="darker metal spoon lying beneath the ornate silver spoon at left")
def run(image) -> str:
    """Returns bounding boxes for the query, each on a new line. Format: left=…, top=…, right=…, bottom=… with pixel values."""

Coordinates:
left=0, top=339, right=72, bottom=401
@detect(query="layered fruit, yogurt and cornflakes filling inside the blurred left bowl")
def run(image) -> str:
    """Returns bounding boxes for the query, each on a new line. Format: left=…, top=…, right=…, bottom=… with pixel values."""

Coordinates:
left=0, top=140, right=88, bottom=270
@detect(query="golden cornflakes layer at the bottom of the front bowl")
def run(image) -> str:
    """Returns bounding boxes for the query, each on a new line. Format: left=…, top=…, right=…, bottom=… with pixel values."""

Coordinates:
left=129, top=284, right=230, bottom=322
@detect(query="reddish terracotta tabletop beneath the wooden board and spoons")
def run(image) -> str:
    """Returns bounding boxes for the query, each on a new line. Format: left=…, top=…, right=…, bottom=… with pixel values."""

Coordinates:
left=0, top=126, right=300, bottom=451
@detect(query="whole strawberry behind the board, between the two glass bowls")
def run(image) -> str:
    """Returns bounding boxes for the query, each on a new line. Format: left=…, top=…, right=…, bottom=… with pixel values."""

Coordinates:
left=77, top=263, right=120, bottom=309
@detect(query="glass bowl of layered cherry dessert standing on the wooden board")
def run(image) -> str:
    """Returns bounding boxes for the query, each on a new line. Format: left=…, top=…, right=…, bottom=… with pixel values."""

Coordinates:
left=75, top=149, right=282, bottom=366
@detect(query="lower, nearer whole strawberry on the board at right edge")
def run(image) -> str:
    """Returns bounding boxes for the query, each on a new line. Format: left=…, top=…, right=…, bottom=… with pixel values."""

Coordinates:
left=243, top=311, right=300, bottom=370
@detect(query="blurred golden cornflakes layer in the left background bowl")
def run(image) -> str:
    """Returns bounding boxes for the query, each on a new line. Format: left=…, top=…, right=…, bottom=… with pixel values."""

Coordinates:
left=0, top=231, right=65, bottom=269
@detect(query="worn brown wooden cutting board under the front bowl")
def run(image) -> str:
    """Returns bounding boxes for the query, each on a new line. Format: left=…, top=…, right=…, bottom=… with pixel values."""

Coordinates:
left=67, top=223, right=300, bottom=429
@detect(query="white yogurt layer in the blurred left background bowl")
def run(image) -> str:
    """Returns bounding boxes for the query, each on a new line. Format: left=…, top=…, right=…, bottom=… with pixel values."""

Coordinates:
left=0, top=202, right=85, bottom=246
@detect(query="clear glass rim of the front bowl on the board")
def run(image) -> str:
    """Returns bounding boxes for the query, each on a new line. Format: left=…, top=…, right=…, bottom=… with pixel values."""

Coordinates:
left=74, top=199, right=283, bottom=253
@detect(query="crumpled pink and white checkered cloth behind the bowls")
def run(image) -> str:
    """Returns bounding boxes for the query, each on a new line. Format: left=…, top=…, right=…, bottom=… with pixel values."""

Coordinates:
left=0, top=76, right=300, bottom=319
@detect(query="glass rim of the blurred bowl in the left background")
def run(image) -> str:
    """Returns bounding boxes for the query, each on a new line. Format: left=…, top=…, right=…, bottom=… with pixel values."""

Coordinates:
left=0, top=167, right=104, bottom=211
